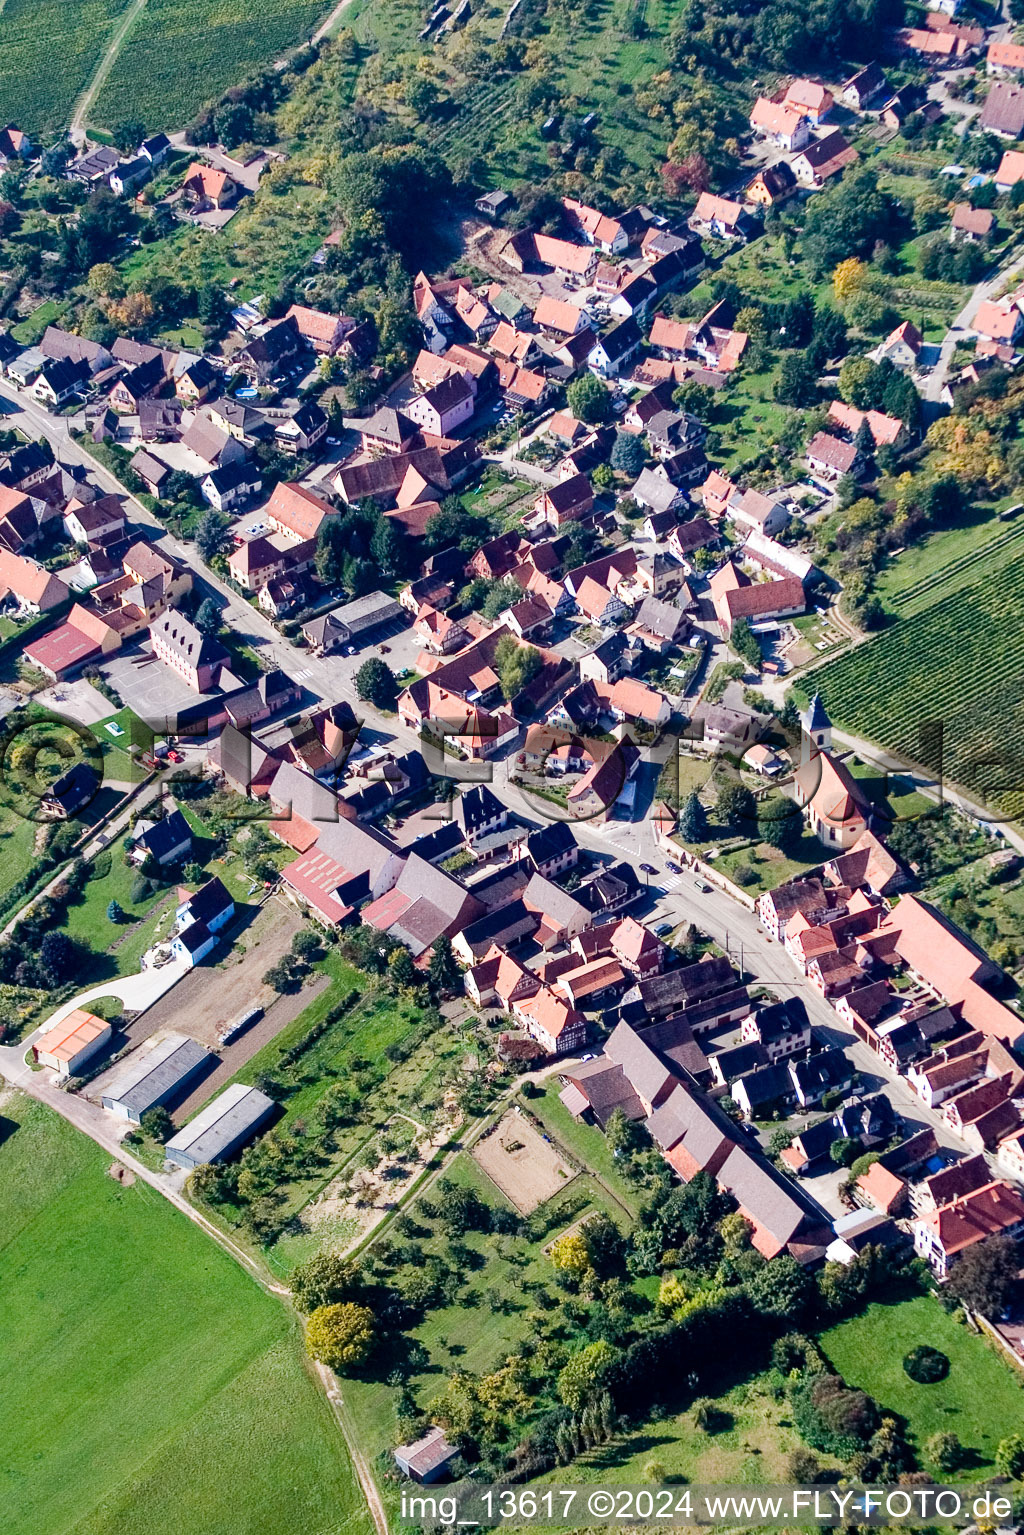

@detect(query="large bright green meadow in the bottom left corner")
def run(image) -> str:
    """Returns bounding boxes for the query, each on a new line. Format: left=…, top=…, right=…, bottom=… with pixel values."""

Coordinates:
left=0, top=1098, right=370, bottom=1535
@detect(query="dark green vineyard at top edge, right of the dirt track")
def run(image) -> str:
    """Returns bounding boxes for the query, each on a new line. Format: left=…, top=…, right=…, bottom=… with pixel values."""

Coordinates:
left=92, top=0, right=330, bottom=132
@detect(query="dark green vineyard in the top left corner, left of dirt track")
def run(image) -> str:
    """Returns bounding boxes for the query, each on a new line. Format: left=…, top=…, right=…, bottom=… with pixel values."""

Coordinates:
left=0, top=0, right=129, bottom=137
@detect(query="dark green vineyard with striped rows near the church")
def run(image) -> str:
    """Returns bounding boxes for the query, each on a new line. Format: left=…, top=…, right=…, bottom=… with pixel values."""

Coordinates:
left=814, top=556, right=1024, bottom=817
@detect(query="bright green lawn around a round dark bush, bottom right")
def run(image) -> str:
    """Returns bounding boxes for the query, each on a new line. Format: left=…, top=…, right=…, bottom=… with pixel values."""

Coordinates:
left=820, top=1296, right=1024, bottom=1481
